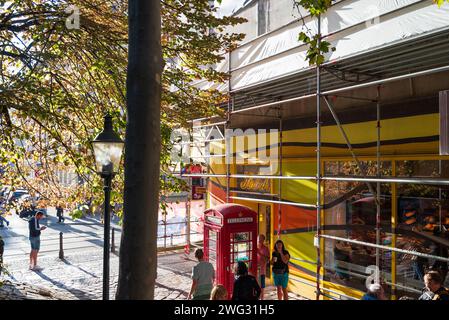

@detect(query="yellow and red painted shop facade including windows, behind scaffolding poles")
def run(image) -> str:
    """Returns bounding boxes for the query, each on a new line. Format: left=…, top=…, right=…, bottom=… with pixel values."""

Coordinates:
left=209, top=104, right=449, bottom=299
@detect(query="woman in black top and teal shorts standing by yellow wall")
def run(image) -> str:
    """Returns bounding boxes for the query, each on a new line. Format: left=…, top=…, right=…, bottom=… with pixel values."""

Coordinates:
left=271, top=240, right=290, bottom=300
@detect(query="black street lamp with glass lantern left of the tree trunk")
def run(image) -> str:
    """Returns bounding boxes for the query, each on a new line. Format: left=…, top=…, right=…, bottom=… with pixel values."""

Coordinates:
left=92, top=114, right=125, bottom=300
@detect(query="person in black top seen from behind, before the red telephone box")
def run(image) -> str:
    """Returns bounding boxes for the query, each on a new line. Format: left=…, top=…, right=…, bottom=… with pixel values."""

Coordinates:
left=232, top=261, right=261, bottom=300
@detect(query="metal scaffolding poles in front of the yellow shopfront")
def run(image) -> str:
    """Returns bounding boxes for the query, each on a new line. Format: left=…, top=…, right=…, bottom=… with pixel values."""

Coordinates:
left=177, top=12, right=449, bottom=300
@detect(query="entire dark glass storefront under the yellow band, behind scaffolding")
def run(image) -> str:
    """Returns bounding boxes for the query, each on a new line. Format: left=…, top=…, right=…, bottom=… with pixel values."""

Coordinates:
left=324, top=160, right=449, bottom=298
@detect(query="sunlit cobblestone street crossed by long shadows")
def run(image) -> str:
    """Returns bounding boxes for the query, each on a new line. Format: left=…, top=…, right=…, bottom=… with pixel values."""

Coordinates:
left=0, top=210, right=302, bottom=300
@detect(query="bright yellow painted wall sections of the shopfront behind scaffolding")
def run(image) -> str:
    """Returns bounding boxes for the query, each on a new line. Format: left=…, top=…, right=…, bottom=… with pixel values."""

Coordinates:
left=206, top=114, right=439, bottom=299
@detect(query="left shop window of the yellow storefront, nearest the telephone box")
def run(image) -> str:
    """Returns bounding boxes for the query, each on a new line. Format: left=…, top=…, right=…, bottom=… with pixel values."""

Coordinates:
left=324, top=181, right=392, bottom=296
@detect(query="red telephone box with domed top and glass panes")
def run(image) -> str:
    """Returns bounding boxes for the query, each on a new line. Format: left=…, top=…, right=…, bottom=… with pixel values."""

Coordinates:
left=204, top=204, right=257, bottom=296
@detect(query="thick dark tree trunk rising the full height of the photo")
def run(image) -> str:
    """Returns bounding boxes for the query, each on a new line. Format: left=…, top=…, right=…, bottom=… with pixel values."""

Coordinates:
left=116, top=0, right=162, bottom=299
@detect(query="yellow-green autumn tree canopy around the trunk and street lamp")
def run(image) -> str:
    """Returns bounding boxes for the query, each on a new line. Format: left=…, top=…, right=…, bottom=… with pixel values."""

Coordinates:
left=0, top=0, right=244, bottom=215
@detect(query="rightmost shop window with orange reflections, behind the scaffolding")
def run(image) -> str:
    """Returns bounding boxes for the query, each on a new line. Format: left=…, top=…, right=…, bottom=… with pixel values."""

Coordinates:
left=396, top=182, right=449, bottom=295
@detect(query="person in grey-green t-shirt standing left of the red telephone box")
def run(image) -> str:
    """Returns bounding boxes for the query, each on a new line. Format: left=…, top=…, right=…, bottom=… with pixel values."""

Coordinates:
left=187, top=249, right=215, bottom=300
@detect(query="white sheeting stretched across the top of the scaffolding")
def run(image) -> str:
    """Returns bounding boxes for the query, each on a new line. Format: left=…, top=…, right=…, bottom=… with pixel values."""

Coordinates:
left=199, top=0, right=449, bottom=91
